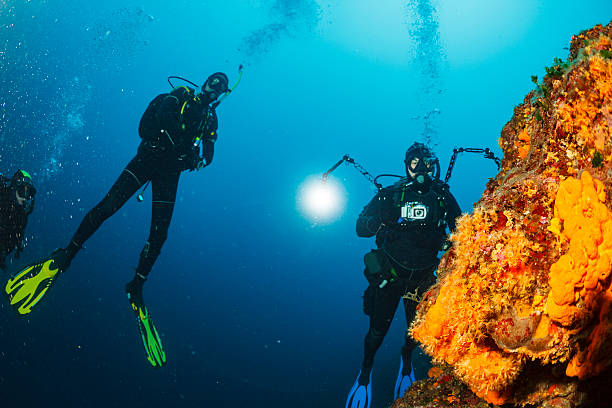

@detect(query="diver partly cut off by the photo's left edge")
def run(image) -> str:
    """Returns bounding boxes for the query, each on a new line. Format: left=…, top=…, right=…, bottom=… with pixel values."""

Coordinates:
left=0, top=170, right=36, bottom=270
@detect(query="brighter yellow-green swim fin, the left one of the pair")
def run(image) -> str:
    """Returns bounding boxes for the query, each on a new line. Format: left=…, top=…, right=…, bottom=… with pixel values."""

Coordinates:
left=4, top=258, right=60, bottom=315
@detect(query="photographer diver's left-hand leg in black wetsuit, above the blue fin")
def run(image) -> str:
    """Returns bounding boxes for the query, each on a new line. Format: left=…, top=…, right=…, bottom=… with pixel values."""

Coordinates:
left=359, top=280, right=402, bottom=385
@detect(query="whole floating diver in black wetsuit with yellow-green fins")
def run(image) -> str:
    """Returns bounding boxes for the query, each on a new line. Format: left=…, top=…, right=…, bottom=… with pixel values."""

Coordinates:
left=6, top=72, right=233, bottom=367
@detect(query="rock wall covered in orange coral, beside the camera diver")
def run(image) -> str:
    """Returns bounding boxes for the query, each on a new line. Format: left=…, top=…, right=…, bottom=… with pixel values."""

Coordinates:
left=411, top=23, right=612, bottom=404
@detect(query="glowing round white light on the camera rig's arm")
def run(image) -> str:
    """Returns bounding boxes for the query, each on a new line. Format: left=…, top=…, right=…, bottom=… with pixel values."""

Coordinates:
left=297, top=176, right=346, bottom=223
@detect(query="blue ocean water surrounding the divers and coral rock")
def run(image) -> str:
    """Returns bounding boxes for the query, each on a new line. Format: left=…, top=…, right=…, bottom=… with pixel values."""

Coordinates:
left=0, top=0, right=612, bottom=408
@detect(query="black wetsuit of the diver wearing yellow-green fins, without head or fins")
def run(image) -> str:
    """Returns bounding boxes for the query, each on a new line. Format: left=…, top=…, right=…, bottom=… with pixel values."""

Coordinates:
left=67, top=87, right=217, bottom=277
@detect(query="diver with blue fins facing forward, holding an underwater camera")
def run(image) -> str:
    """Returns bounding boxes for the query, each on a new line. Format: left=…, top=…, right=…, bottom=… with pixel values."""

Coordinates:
left=346, top=143, right=461, bottom=408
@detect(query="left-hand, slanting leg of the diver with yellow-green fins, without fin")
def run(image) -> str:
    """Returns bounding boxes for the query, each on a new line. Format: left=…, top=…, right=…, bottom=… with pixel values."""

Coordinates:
left=56, top=154, right=150, bottom=270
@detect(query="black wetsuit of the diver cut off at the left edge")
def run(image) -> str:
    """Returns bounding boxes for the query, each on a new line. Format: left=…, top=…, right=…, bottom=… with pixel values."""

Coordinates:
left=0, top=176, right=28, bottom=269
